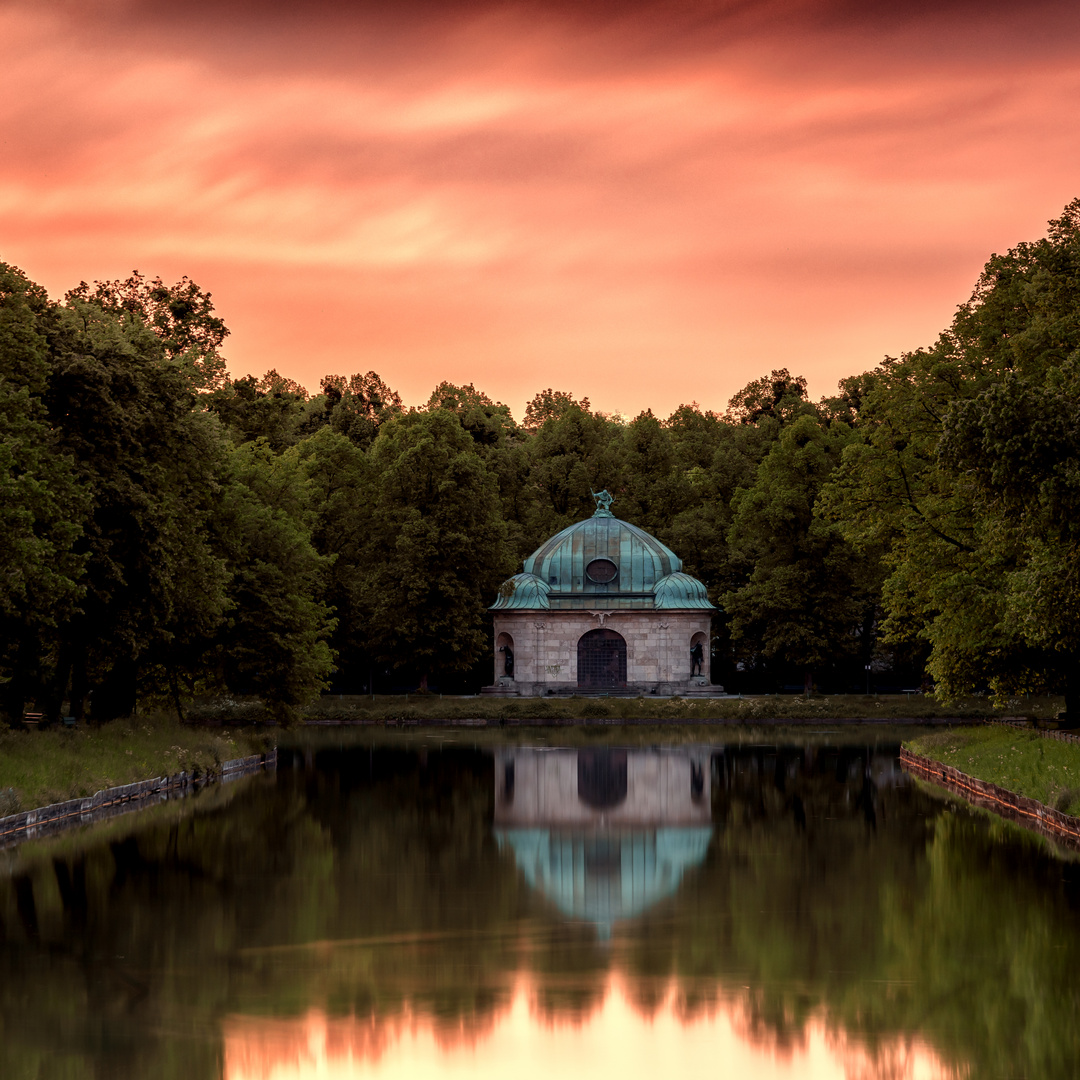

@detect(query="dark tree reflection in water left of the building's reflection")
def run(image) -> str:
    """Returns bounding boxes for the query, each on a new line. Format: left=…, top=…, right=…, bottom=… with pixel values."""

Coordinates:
left=0, top=753, right=516, bottom=1078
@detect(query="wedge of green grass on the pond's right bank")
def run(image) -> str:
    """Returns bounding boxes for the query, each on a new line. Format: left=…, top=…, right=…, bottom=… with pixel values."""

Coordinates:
left=904, top=725, right=1080, bottom=815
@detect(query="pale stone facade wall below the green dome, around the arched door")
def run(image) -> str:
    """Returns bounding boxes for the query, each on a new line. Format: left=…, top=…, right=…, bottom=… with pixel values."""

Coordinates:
left=492, top=609, right=723, bottom=697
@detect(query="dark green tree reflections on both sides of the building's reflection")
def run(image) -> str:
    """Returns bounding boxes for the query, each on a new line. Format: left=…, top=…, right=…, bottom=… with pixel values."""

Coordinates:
left=0, top=750, right=1080, bottom=1080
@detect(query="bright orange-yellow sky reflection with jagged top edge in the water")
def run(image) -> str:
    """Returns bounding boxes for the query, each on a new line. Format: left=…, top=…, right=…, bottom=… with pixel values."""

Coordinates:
left=225, top=978, right=955, bottom=1080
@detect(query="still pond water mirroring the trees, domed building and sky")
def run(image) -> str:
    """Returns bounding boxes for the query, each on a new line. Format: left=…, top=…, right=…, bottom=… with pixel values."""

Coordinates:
left=0, top=739, right=1080, bottom=1080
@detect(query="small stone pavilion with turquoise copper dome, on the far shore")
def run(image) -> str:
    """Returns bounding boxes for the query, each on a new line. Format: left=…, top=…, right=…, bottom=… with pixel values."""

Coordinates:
left=485, top=500, right=724, bottom=697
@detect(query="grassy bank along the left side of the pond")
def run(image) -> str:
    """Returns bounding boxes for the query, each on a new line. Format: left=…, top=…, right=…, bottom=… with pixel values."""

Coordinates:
left=0, top=715, right=266, bottom=816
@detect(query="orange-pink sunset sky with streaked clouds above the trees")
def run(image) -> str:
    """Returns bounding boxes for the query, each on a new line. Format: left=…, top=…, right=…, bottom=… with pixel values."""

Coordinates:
left=0, top=0, right=1080, bottom=418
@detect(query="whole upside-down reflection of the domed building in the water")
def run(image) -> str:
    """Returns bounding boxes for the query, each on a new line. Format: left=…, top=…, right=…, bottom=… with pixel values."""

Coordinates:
left=495, top=750, right=713, bottom=934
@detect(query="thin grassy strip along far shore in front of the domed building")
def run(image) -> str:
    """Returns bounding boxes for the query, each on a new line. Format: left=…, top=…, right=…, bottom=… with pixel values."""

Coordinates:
left=293, top=694, right=1063, bottom=724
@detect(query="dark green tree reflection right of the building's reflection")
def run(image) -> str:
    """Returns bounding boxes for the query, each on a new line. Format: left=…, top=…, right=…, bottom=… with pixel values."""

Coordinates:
left=630, top=750, right=1080, bottom=1078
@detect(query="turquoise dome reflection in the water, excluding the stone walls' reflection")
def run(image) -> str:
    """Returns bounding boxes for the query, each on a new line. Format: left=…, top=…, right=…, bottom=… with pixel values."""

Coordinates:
left=496, top=825, right=713, bottom=934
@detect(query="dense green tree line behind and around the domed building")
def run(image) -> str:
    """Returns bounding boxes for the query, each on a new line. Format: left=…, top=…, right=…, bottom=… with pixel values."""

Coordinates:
left=6, top=200, right=1080, bottom=720
